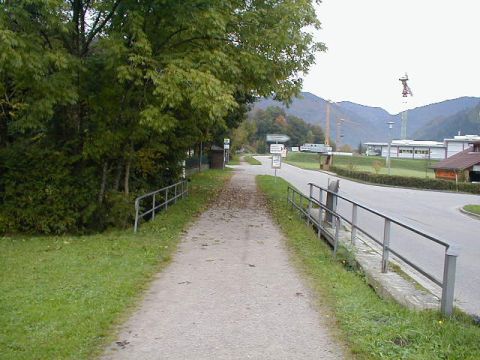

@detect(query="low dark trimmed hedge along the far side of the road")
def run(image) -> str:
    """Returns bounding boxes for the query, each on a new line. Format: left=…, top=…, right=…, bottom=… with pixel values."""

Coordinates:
left=330, top=166, right=480, bottom=194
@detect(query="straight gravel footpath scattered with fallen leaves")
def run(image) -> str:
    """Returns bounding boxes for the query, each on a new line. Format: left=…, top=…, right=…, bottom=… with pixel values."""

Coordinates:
left=103, top=172, right=344, bottom=359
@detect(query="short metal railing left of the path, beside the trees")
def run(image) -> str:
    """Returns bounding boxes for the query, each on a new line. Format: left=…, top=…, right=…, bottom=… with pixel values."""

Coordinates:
left=133, top=180, right=188, bottom=233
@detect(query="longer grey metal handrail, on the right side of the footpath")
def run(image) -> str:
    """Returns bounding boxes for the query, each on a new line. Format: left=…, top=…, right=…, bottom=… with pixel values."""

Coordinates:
left=287, top=183, right=459, bottom=315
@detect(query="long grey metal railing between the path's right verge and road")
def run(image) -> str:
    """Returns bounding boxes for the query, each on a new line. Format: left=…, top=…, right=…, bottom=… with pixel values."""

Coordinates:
left=287, top=183, right=459, bottom=315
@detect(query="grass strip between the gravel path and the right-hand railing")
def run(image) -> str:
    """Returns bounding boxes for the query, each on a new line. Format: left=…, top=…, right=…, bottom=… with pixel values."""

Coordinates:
left=257, top=176, right=480, bottom=360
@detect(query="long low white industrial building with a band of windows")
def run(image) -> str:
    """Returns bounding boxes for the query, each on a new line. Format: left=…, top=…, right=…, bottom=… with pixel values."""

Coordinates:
left=364, top=135, right=480, bottom=160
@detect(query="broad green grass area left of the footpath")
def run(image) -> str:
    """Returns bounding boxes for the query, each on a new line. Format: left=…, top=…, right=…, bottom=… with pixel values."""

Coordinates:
left=0, top=170, right=230, bottom=359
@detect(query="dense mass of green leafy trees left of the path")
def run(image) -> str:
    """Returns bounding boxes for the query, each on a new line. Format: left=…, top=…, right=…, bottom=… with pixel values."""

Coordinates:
left=0, top=0, right=324, bottom=233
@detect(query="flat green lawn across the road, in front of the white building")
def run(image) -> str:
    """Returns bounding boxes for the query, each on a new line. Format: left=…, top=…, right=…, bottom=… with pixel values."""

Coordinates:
left=287, top=152, right=437, bottom=178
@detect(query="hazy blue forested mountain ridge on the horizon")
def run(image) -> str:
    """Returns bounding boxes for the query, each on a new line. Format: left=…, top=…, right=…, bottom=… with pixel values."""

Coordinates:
left=252, top=92, right=480, bottom=146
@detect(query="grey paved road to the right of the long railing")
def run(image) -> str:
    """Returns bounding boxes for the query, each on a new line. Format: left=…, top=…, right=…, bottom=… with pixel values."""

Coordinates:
left=243, top=157, right=480, bottom=315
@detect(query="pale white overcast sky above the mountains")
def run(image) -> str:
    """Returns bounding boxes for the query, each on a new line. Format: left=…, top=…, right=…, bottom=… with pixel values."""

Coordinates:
left=303, top=0, right=480, bottom=114
